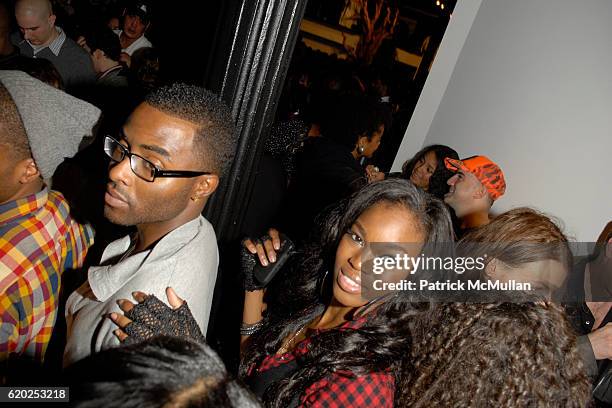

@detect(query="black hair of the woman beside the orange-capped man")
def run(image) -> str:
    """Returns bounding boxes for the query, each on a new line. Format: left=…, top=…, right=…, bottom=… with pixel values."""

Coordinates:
left=402, top=145, right=459, bottom=200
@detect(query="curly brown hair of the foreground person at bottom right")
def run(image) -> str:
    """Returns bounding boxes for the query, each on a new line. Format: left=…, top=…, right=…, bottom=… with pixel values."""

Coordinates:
left=397, top=302, right=591, bottom=408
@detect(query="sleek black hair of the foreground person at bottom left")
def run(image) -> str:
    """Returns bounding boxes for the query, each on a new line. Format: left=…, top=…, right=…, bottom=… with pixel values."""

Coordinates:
left=66, top=337, right=260, bottom=408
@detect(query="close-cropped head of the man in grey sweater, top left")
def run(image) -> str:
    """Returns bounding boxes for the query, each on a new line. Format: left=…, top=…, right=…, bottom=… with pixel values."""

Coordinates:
left=15, top=0, right=57, bottom=46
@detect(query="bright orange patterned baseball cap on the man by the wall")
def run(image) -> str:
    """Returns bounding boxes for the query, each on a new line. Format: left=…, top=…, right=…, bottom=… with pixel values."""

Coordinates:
left=444, top=156, right=506, bottom=200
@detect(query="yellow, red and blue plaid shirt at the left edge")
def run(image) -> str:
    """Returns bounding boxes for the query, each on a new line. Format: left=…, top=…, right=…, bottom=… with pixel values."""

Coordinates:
left=0, top=187, right=93, bottom=361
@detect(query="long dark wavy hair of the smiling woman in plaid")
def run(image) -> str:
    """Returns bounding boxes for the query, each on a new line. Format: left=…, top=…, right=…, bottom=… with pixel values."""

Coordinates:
left=240, top=179, right=453, bottom=407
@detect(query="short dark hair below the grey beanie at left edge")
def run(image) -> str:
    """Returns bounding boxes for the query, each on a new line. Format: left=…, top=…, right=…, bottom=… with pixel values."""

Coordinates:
left=0, top=82, right=32, bottom=159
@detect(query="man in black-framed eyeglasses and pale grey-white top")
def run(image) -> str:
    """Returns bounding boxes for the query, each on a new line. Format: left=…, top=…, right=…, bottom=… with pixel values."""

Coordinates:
left=64, top=84, right=235, bottom=365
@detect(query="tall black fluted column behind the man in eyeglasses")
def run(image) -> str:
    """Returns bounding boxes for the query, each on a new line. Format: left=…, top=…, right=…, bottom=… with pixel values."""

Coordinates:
left=204, top=0, right=306, bottom=371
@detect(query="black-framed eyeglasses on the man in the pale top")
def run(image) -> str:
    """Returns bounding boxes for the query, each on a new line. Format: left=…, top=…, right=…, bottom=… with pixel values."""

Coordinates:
left=104, top=136, right=212, bottom=182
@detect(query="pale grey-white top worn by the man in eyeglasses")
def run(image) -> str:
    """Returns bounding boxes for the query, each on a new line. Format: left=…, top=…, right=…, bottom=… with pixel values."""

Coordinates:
left=64, top=216, right=219, bottom=366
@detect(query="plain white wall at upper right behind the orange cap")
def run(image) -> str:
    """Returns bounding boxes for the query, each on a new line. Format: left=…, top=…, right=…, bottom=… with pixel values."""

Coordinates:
left=393, top=0, right=612, bottom=241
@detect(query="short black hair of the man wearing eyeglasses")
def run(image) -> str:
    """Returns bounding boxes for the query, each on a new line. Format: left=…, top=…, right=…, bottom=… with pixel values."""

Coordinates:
left=145, top=83, right=236, bottom=176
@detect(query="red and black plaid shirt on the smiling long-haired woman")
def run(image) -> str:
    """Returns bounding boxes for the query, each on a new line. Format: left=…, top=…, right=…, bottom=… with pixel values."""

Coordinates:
left=251, top=317, right=395, bottom=408
